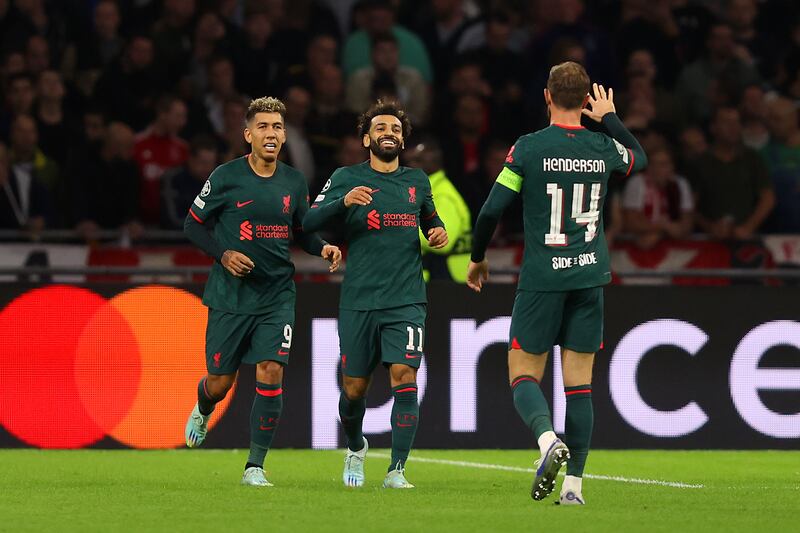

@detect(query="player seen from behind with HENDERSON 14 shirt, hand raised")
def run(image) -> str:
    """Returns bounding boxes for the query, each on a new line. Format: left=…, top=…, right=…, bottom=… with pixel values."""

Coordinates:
left=467, top=62, right=647, bottom=504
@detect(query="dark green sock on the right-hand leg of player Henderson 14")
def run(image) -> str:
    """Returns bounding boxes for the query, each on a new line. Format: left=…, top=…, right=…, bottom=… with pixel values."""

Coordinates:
left=564, top=385, right=594, bottom=477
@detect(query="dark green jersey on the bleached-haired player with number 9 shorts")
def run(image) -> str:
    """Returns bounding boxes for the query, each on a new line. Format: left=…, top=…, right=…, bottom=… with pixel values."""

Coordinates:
left=190, top=156, right=308, bottom=315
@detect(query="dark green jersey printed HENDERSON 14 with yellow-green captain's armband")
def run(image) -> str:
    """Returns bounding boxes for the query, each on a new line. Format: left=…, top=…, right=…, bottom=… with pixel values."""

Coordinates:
left=497, top=125, right=634, bottom=291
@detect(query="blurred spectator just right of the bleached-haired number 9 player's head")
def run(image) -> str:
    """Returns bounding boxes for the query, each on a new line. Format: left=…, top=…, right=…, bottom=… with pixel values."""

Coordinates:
left=281, top=87, right=316, bottom=184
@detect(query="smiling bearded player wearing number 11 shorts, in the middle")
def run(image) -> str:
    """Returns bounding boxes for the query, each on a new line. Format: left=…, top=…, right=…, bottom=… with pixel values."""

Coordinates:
left=303, top=100, right=447, bottom=488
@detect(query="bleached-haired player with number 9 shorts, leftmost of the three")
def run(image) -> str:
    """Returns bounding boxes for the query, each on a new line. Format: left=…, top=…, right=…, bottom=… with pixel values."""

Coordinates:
left=184, top=97, right=341, bottom=487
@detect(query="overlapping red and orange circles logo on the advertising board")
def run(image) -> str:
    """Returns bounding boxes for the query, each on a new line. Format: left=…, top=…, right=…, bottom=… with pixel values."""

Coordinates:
left=0, top=285, right=234, bottom=448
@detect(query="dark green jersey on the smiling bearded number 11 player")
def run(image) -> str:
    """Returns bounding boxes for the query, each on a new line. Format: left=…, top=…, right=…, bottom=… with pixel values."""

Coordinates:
left=303, top=162, right=443, bottom=311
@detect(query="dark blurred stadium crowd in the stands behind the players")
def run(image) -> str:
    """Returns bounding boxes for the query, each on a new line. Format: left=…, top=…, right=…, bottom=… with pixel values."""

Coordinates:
left=0, top=0, right=800, bottom=244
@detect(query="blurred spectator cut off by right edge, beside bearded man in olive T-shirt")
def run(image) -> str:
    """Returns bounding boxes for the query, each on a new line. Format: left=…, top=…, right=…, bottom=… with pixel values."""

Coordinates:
left=761, top=98, right=800, bottom=233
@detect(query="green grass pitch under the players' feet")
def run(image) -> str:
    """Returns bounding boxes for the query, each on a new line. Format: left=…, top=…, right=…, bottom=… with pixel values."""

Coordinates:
left=0, top=450, right=800, bottom=533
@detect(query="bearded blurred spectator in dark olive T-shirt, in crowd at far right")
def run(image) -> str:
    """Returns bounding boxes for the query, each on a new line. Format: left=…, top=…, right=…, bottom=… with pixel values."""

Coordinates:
left=692, top=108, right=775, bottom=239
